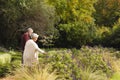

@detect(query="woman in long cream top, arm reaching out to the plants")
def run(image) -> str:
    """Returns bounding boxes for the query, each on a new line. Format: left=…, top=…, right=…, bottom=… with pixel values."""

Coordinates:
left=23, top=33, right=45, bottom=66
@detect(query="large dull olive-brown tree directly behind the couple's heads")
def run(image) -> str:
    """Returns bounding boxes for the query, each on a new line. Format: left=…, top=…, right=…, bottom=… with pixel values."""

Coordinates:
left=0, top=0, right=54, bottom=46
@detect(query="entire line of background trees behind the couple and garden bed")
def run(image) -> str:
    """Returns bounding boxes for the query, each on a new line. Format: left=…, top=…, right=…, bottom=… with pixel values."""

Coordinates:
left=0, top=0, right=120, bottom=48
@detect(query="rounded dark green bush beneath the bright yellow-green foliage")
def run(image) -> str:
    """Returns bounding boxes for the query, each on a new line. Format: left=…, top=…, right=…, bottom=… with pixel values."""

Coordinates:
left=59, top=21, right=95, bottom=47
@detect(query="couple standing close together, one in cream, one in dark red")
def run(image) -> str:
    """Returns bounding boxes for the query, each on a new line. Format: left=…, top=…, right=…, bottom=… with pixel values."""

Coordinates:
left=21, top=28, right=45, bottom=66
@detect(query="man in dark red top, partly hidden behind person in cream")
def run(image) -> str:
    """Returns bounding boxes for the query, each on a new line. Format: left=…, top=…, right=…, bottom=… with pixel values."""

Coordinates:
left=21, top=28, right=33, bottom=64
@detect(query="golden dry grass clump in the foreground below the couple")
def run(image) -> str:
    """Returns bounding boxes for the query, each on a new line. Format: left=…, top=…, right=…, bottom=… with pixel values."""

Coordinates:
left=15, top=67, right=58, bottom=80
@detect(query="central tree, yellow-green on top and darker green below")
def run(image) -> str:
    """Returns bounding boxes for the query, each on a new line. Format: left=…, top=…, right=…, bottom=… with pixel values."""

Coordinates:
left=48, top=0, right=96, bottom=47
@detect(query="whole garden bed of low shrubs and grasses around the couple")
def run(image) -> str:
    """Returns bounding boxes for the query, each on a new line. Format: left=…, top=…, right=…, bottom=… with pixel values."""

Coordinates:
left=0, top=46, right=120, bottom=80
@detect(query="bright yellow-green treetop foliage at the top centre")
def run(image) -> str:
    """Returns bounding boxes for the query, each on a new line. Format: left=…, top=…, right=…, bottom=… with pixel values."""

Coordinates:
left=48, top=0, right=96, bottom=23
